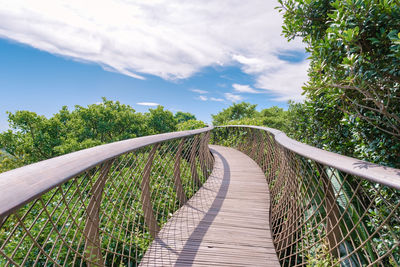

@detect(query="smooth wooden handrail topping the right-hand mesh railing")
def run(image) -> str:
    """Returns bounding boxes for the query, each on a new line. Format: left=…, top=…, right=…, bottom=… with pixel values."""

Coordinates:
left=217, top=125, right=400, bottom=190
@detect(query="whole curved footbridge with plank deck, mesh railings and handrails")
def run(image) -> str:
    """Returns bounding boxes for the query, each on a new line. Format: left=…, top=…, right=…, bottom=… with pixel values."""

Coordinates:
left=0, top=126, right=400, bottom=267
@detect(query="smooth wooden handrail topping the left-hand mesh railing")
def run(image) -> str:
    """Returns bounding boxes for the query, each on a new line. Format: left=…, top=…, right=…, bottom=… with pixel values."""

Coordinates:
left=0, top=126, right=214, bottom=218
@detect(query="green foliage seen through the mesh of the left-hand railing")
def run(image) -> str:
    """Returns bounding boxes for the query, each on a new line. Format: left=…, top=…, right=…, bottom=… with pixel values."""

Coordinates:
left=0, top=137, right=211, bottom=266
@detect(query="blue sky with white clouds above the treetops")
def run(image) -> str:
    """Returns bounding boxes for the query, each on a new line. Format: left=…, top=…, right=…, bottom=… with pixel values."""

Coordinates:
left=0, top=0, right=309, bottom=131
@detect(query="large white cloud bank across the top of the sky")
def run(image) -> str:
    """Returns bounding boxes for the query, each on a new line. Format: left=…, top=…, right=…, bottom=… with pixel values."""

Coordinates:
left=0, top=0, right=307, bottom=98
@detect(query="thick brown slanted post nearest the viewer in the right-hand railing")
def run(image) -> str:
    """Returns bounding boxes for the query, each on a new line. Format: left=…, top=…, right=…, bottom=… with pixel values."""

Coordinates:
left=316, top=162, right=343, bottom=258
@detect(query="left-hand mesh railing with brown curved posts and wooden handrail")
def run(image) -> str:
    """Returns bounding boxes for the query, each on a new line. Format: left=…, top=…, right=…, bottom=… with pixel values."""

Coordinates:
left=0, top=129, right=213, bottom=266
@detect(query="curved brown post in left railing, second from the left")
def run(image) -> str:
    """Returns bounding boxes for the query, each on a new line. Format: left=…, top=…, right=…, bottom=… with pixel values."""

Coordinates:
left=140, top=144, right=160, bottom=238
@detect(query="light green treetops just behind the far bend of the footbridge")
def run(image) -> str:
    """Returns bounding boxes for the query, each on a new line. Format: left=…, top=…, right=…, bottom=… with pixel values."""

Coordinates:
left=212, top=102, right=288, bottom=131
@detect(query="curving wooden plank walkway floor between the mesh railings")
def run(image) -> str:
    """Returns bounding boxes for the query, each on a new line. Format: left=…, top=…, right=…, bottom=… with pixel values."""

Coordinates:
left=141, top=146, right=279, bottom=266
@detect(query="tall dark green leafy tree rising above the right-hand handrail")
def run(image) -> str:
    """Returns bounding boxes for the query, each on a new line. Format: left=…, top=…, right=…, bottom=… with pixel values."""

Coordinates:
left=279, top=0, right=400, bottom=166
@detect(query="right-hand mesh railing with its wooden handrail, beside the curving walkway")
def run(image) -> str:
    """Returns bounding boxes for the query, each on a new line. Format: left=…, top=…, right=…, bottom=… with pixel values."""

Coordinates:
left=212, top=126, right=400, bottom=266
